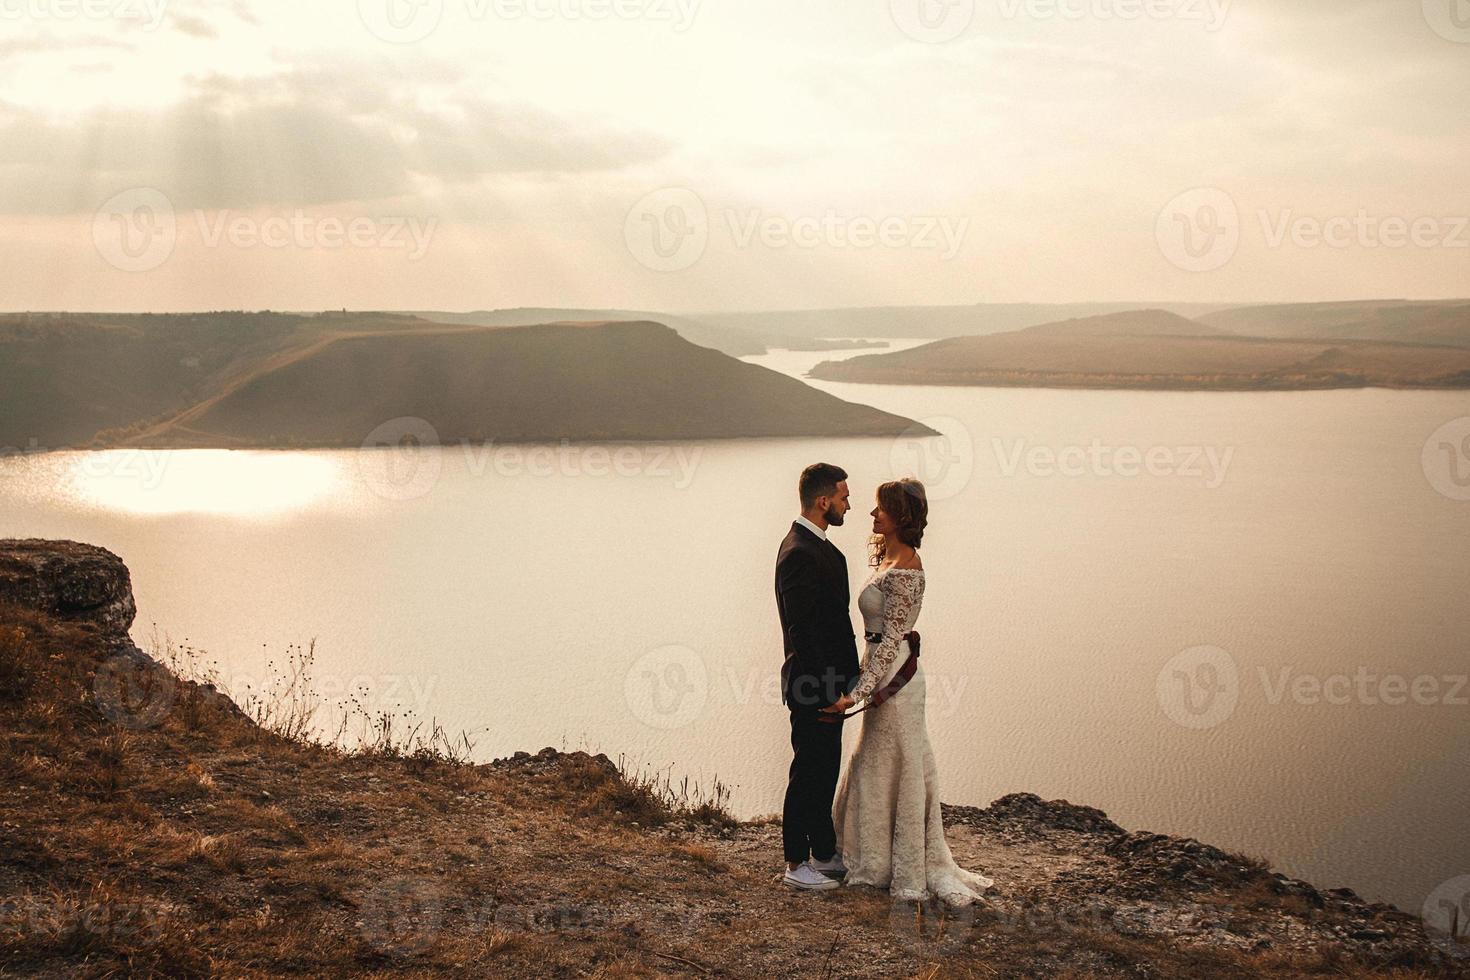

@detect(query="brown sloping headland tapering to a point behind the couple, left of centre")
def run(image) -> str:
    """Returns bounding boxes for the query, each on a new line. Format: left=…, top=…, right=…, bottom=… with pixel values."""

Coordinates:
left=126, top=322, right=929, bottom=447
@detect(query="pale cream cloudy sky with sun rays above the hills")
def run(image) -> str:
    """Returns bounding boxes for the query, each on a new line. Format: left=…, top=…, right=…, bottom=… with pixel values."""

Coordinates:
left=0, top=0, right=1470, bottom=310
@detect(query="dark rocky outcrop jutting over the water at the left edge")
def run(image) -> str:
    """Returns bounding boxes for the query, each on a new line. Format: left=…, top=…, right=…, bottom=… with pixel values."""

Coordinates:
left=0, top=538, right=138, bottom=638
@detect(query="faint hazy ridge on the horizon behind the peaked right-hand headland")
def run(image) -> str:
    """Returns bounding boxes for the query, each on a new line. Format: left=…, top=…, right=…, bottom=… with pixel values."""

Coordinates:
left=692, top=303, right=1229, bottom=338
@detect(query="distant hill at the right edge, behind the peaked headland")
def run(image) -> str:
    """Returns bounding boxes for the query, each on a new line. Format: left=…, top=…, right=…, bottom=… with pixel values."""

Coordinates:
left=1200, top=300, right=1470, bottom=347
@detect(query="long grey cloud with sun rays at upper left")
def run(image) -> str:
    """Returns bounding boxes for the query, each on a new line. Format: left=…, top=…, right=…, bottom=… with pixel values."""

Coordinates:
left=0, top=66, right=670, bottom=215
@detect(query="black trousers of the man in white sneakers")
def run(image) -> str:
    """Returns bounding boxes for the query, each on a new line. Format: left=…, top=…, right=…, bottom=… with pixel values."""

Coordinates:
left=781, top=708, right=842, bottom=864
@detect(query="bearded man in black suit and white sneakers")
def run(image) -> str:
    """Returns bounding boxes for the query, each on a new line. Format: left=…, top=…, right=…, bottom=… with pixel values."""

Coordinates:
left=776, top=463, right=858, bottom=890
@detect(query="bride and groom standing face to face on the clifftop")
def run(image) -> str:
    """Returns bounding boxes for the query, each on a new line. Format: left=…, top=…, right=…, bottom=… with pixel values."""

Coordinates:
left=776, top=463, right=994, bottom=907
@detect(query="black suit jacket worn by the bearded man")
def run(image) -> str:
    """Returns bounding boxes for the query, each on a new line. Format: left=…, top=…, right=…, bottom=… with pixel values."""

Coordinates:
left=776, top=522, right=858, bottom=711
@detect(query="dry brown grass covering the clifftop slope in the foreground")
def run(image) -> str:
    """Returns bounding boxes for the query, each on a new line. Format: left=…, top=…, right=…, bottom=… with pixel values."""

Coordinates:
left=0, top=608, right=1452, bottom=980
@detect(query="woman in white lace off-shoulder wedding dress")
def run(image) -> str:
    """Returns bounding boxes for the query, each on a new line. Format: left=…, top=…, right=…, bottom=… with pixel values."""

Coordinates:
left=832, top=479, right=994, bottom=907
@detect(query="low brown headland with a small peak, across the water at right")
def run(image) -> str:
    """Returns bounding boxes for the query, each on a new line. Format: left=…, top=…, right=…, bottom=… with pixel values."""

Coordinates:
left=811, top=310, right=1470, bottom=391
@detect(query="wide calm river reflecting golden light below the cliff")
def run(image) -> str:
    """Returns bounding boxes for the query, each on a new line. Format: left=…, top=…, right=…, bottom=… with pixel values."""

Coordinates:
left=0, top=342, right=1470, bottom=912
